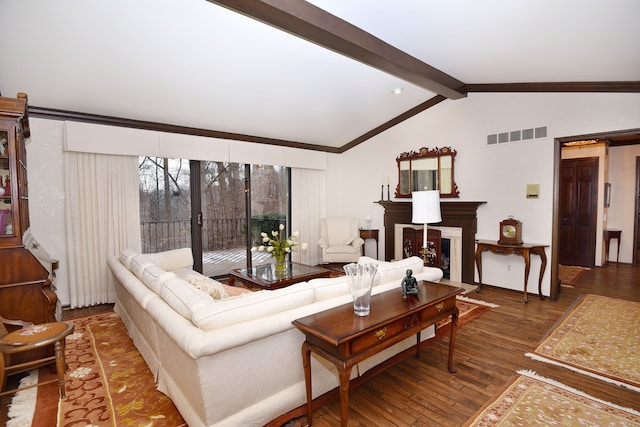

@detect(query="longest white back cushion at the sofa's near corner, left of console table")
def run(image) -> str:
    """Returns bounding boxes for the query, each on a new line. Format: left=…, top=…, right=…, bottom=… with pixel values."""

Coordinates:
left=191, top=282, right=314, bottom=331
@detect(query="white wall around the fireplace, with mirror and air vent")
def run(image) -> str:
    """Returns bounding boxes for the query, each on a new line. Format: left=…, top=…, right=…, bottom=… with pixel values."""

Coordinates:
left=327, top=93, right=640, bottom=295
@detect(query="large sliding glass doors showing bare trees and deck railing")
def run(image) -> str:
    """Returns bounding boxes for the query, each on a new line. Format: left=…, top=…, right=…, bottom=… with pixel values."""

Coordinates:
left=140, top=157, right=290, bottom=277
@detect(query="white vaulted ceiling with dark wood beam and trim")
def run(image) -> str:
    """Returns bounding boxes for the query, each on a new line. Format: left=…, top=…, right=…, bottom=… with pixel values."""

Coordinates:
left=0, top=0, right=640, bottom=152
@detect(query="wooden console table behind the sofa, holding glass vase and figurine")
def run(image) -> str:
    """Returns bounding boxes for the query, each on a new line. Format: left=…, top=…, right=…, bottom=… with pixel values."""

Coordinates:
left=293, top=281, right=464, bottom=426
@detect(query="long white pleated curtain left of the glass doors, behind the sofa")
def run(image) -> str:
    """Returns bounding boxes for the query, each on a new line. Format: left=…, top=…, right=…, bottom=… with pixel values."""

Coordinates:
left=64, top=151, right=141, bottom=308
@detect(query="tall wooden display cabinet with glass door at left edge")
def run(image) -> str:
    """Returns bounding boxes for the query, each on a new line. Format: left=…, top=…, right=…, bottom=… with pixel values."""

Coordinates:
left=0, top=94, right=58, bottom=323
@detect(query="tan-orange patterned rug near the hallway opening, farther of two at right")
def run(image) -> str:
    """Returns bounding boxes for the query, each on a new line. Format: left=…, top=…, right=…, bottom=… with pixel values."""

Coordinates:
left=527, top=294, right=640, bottom=391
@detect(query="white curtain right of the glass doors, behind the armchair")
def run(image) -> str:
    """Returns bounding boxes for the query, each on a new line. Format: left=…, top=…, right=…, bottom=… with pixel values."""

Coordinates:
left=291, top=168, right=326, bottom=265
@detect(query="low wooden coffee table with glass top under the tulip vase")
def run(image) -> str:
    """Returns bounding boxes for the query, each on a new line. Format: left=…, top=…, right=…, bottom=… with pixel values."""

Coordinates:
left=230, top=262, right=331, bottom=289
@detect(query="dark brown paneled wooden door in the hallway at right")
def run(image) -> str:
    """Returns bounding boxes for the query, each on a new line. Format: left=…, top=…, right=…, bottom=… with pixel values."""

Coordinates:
left=558, top=157, right=598, bottom=267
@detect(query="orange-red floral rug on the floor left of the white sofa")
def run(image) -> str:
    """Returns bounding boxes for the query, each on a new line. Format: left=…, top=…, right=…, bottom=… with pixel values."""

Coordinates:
left=56, top=312, right=186, bottom=427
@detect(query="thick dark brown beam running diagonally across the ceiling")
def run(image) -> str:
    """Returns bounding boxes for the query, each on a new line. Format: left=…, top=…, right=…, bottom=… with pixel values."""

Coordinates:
left=208, top=0, right=466, bottom=99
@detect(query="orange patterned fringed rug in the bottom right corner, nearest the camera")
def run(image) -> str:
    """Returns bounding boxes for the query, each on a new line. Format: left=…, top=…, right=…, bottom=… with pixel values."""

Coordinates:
left=465, top=371, right=640, bottom=427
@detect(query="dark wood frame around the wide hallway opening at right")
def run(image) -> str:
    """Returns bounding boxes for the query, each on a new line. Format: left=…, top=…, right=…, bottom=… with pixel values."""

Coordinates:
left=549, top=128, right=640, bottom=301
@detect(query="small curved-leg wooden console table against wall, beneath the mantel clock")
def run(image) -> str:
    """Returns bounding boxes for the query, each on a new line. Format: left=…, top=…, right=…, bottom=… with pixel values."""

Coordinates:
left=475, top=240, right=549, bottom=303
